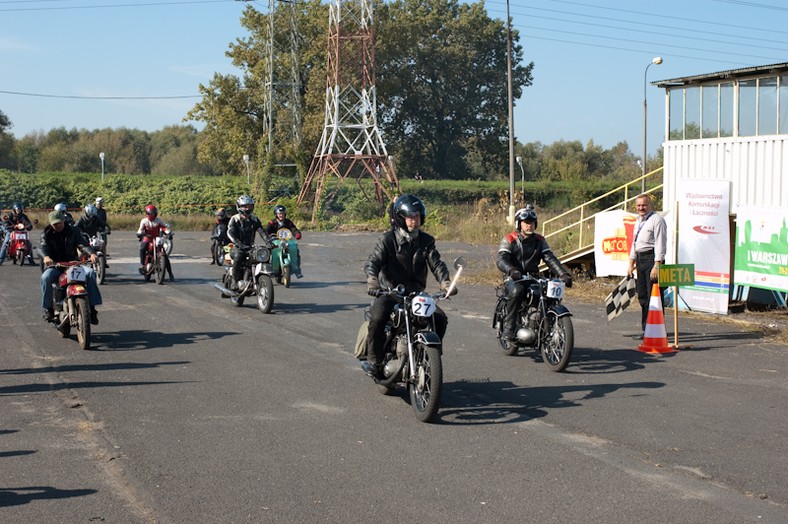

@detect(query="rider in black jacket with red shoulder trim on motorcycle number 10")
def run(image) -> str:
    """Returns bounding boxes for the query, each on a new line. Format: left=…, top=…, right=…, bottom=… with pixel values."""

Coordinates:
left=495, top=204, right=572, bottom=340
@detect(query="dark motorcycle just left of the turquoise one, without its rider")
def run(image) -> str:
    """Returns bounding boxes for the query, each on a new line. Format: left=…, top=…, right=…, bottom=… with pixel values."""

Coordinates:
left=214, top=243, right=274, bottom=313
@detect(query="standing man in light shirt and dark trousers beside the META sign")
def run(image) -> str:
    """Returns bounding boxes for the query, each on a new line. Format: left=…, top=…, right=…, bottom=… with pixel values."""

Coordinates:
left=627, top=194, right=668, bottom=340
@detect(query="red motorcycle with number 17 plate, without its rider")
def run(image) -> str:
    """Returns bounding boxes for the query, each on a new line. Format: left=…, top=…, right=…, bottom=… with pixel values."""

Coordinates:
left=47, top=261, right=90, bottom=349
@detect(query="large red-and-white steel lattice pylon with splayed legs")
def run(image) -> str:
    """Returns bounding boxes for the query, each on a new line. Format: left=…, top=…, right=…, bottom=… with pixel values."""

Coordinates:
left=298, top=0, right=399, bottom=220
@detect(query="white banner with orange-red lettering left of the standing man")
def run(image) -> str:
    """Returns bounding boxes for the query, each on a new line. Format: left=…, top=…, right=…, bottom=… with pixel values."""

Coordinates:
left=594, top=210, right=637, bottom=277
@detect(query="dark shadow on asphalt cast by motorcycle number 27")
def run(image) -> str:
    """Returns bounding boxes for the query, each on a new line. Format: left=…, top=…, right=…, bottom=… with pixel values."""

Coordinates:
left=436, top=380, right=665, bottom=425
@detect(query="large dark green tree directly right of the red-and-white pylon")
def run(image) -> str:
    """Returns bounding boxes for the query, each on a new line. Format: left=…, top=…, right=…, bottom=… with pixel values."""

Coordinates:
left=375, top=0, right=533, bottom=178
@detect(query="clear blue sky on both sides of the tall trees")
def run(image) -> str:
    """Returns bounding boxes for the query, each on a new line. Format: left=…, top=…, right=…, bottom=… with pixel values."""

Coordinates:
left=0, top=0, right=788, bottom=155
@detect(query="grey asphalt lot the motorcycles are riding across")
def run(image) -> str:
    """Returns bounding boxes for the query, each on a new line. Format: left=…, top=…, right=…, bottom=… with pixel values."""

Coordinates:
left=0, top=232, right=788, bottom=524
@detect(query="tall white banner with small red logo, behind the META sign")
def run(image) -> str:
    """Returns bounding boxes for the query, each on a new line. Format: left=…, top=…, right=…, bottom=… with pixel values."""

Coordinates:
left=676, top=179, right=730, bottom=315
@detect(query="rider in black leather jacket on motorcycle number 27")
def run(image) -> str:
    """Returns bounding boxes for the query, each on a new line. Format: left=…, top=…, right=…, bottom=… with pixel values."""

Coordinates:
left=361, top=194, right=457, bottom=379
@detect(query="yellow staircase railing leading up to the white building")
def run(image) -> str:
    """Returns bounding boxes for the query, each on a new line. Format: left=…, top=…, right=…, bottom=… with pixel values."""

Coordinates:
left=541, top=167, right=664, bottom=261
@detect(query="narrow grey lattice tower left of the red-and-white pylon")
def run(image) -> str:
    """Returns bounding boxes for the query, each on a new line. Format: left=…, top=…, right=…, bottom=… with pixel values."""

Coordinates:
left=263, top=0, right=302, bottom=171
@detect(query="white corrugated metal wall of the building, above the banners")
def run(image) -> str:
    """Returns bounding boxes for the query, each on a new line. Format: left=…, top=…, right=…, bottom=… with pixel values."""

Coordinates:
left=663, top=135, right=788, bottom=214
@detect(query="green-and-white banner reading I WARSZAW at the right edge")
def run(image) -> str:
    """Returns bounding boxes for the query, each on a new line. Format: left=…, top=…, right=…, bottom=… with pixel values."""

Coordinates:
left=733, top=208, right=788, bottom=291
